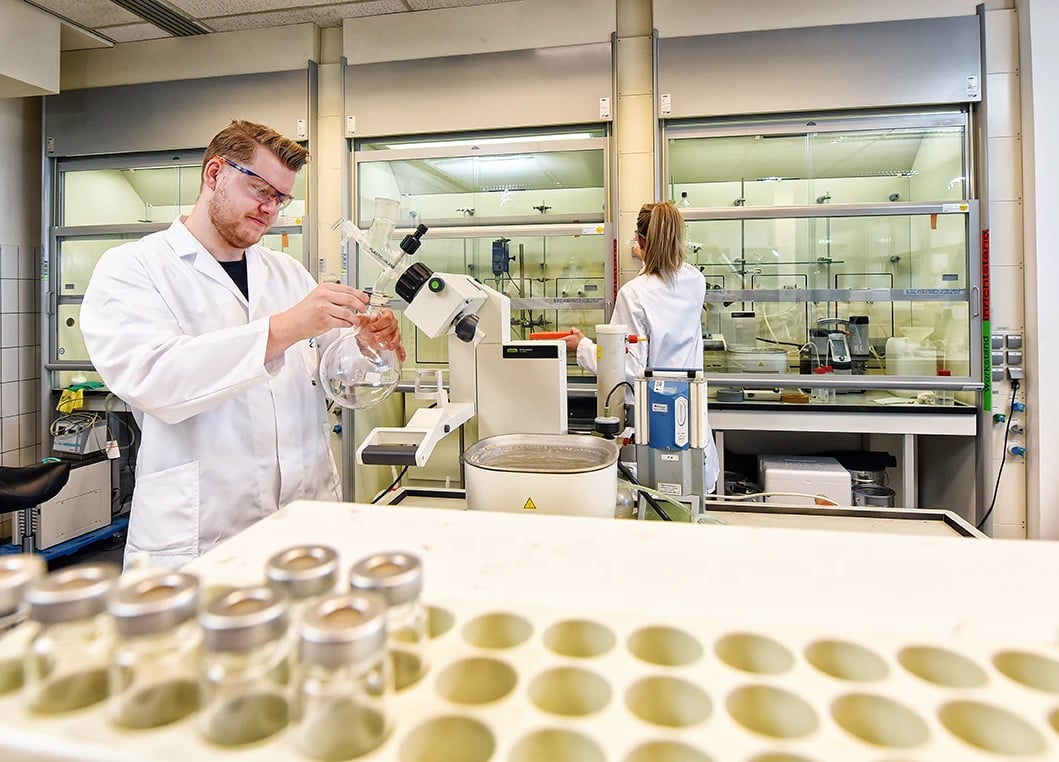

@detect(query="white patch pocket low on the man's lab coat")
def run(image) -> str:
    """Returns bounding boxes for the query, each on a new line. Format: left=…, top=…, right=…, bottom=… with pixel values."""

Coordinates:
left=128, top=460, right=199, bottom=555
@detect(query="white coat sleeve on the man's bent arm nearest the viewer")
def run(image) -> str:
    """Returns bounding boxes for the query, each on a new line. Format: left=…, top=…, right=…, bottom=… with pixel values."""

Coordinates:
left=80, top=249, right=283, bottom=423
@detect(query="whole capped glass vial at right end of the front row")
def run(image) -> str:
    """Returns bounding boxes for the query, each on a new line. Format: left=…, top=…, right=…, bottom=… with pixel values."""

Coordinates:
left=295, top=591, right=393, bottom=760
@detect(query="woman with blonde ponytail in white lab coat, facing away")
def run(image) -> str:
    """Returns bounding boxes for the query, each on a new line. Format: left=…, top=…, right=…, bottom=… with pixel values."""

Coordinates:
left=567, top=202, right=720, bottom=492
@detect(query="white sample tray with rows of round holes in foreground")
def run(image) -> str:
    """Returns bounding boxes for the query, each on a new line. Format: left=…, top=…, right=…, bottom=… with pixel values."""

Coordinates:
left=0, top=504, right=1059, bottom=762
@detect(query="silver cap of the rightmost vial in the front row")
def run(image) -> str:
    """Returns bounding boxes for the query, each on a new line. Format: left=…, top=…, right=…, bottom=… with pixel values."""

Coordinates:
left=299, top=591, right=387, bottom=668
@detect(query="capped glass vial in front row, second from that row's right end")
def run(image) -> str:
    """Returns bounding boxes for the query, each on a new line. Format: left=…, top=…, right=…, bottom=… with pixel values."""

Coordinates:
left=198, top=585, right=290, bottom=746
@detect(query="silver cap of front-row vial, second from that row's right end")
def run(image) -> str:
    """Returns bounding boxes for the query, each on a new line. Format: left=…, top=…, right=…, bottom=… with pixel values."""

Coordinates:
left=199, top=585, right=287, bottom=651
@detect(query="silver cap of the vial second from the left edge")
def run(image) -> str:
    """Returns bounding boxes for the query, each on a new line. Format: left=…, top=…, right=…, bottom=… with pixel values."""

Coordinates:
left=23, top=563, right=122, bottom=624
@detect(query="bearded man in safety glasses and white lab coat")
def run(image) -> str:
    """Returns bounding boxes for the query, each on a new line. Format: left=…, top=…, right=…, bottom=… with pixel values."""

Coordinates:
left=80, top=122, right=403, bottom=567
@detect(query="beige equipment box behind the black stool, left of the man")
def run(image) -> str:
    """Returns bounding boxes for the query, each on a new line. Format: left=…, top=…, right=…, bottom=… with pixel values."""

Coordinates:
left=14, top=460, right=110, bottom=550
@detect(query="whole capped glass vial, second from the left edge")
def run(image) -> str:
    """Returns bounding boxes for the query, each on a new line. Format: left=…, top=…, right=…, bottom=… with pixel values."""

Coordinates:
left=22, top=563, right=121, bottom=713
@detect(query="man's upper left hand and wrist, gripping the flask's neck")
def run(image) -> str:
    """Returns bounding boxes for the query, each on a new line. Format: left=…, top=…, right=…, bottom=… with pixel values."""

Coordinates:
left=265, top=284, right=370, bottom=362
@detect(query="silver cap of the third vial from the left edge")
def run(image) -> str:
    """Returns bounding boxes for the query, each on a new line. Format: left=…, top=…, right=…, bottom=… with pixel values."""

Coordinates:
left=107, top=572, right=199, bottom=637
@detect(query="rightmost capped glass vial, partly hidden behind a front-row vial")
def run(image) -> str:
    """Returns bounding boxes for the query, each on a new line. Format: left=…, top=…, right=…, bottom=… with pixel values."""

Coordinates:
left=349, top=552, right=428, bottom=690
